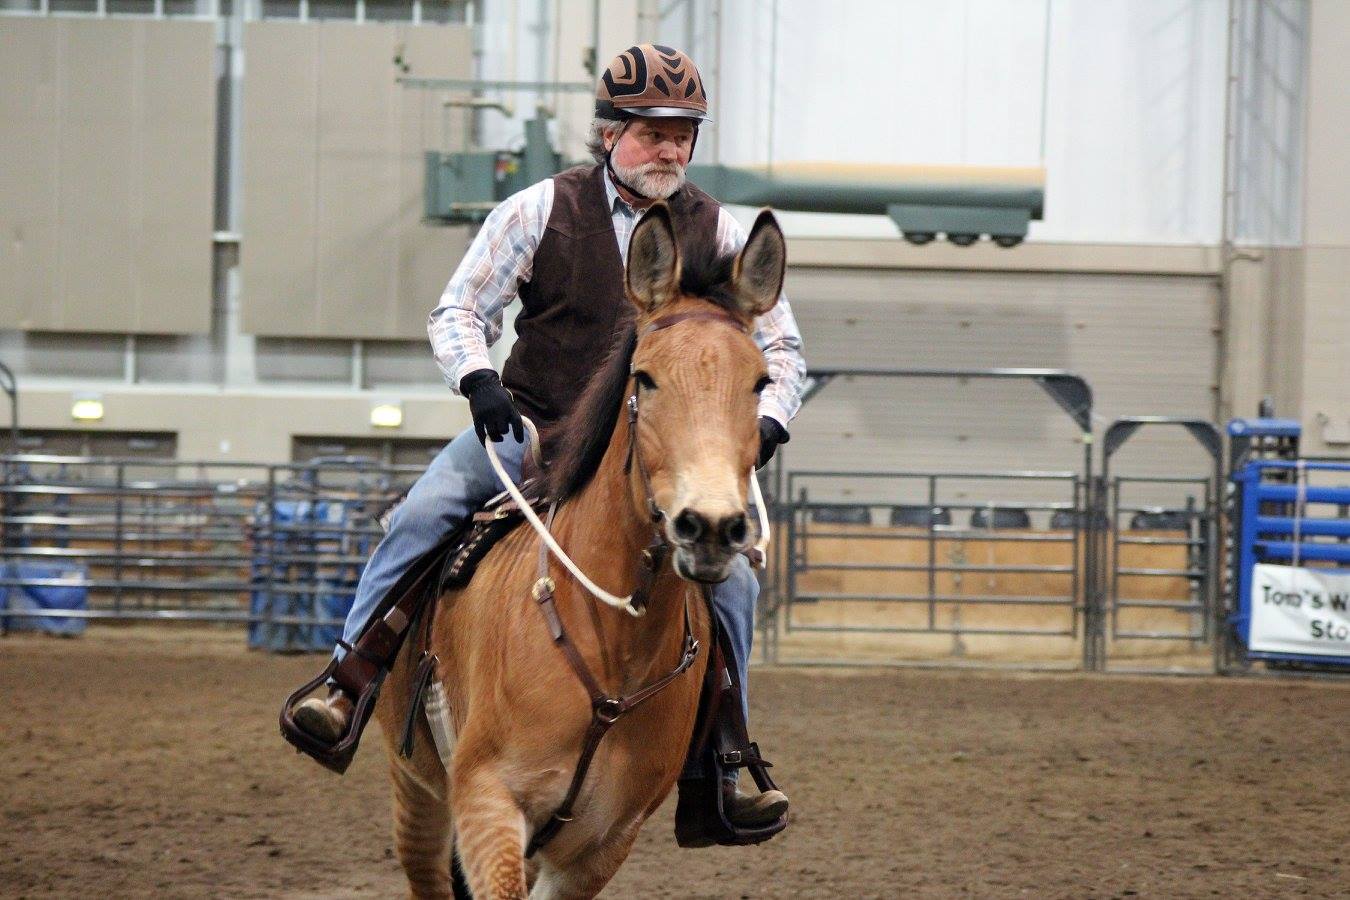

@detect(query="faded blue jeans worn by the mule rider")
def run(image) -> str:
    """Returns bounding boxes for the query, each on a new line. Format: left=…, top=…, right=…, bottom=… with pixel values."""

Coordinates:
left=336, top=428, right=759, bottom=715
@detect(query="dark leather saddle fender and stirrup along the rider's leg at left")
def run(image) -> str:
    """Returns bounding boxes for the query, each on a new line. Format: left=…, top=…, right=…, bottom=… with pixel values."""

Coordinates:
left=281, top=480, right=547, bottom=775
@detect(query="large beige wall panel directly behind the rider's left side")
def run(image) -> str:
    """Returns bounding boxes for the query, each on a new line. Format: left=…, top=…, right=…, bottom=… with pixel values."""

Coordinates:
left=240, top=22, right=471, bottom=339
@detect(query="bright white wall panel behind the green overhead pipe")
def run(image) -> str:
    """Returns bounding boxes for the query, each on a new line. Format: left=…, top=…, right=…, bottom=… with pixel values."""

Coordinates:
left=648, top=0, right=1227, bottom=243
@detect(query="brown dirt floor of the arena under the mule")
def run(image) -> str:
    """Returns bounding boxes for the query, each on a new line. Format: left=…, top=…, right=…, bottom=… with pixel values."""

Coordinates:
left=0, top=627, right=1350, bottom=899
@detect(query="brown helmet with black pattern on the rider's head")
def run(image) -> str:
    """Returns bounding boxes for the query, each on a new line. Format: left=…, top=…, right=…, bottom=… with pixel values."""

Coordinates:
left=595, top=43, right=707, bottom=123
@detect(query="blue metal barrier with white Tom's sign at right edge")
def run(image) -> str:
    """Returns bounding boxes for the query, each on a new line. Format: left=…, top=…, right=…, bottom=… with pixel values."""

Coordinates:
left=1224, top=459, right=1350, bottom=668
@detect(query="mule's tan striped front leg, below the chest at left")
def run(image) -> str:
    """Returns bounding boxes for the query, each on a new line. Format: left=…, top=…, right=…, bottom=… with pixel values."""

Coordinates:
left=451, top=761, right=529, bottom=900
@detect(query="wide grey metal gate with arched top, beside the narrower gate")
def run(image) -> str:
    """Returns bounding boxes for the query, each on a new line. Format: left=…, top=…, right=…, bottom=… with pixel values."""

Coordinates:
left=760, top=368, right=1100, bottom=668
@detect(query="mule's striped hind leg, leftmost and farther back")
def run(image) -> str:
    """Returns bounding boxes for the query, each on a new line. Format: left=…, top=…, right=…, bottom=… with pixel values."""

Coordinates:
left=390, top=755, right=454, bottom=899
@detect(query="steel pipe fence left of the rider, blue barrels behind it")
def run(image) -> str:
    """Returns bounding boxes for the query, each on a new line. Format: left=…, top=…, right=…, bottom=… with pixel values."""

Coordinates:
left=0, top=455, right=423, bottom=644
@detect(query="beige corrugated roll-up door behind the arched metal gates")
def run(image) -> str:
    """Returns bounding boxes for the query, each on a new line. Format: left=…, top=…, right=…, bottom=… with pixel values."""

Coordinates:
left=787, top=269, right=1218, bottom=502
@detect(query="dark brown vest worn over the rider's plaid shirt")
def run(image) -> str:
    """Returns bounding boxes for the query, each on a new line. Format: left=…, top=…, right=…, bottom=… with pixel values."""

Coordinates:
left=502, top=166, right=720, bottom=456
